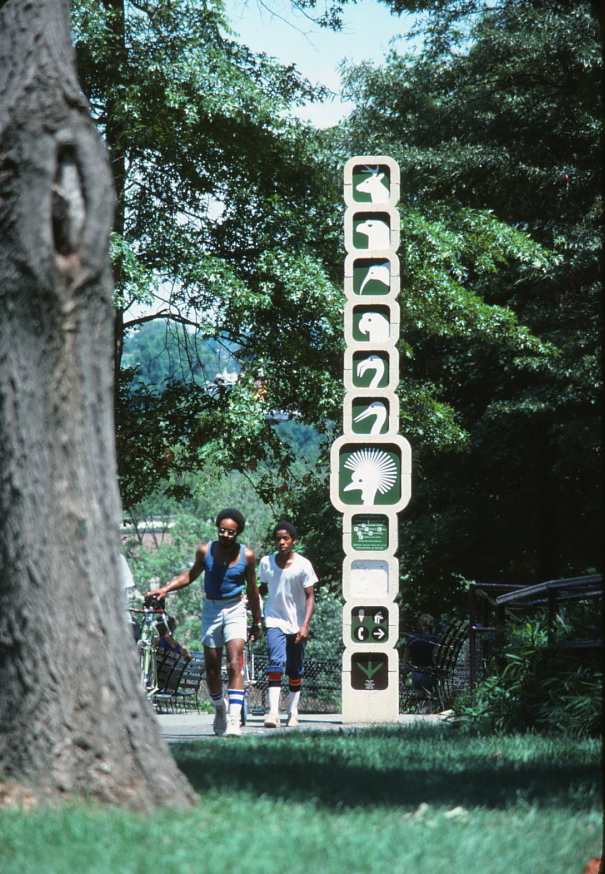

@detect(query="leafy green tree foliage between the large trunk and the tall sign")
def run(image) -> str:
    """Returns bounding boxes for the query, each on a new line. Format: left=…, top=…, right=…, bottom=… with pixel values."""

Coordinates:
left=74, top=0, right=340, bottom=507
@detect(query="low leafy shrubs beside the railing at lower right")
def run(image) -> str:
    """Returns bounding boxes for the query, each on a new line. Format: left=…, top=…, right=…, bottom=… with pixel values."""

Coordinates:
left=469, top=622, right=603, bottom=737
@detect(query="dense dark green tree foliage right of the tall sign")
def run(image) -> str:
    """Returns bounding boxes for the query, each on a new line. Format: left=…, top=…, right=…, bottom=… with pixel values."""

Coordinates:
left=339, top=0, right=602, bottom=600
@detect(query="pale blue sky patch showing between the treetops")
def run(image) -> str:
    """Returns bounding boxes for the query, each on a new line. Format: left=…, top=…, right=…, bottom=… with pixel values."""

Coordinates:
left=225, top=0, right=412, bottom=127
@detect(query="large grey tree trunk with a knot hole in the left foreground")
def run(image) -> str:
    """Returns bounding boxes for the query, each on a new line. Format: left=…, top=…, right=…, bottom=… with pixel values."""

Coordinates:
left=0, top=0, right=194, bottom=808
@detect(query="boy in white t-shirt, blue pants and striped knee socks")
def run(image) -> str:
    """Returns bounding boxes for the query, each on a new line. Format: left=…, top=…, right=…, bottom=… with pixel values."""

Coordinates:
left=258, top=522, right=317, bottom=728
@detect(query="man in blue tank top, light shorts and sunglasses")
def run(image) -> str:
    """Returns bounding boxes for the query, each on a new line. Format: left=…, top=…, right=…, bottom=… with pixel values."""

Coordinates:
left=147, top=508, right=262, bottom=737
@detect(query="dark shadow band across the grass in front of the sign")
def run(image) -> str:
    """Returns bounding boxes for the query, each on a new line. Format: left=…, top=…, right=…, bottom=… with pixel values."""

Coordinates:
left=173, top=727, right=600, bottom=811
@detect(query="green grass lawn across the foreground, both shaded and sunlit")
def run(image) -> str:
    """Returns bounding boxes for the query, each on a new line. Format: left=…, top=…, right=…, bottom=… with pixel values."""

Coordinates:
left=0, top=725, right=602, bottom=874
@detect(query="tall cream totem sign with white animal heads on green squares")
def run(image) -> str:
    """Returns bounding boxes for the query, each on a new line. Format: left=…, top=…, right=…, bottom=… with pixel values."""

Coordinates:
left=330, top=156, right=411, bottom=723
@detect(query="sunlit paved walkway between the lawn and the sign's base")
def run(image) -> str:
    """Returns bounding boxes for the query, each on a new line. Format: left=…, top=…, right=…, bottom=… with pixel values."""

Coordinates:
left=157, top=713, right=447, bottom=743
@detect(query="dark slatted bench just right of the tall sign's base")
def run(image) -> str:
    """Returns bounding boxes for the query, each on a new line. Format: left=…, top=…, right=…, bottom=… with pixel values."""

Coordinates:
left=399, top=619, right=470, bottom=713
